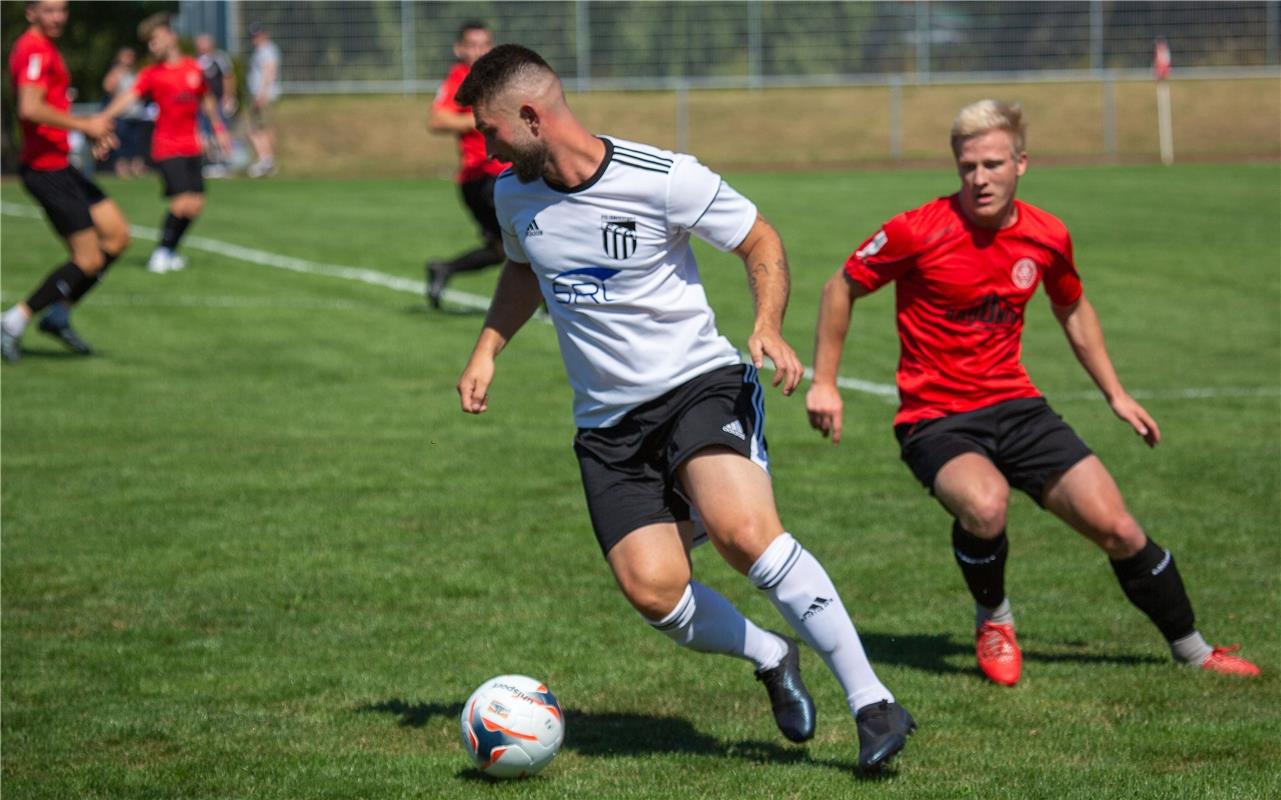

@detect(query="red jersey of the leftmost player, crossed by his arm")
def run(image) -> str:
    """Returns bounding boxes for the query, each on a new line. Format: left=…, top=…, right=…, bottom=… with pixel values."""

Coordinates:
left=9, top=28, right=72, bottom=170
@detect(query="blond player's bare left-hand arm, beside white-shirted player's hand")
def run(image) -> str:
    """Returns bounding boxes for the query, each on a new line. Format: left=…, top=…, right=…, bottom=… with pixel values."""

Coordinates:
left=804, top=269, right=867, bottom=444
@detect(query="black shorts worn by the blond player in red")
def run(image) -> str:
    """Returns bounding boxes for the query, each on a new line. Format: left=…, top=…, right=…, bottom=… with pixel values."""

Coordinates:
left=894, top=397, right=1091, bottom=507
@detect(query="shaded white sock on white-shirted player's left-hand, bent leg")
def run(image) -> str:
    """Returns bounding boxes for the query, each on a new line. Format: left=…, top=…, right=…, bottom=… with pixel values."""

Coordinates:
left=646, top=581, right=788, bottom=671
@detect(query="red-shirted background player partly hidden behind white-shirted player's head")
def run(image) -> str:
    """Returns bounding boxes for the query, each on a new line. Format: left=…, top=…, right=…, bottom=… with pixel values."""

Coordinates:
left=427, top=22, right=507, bottom=308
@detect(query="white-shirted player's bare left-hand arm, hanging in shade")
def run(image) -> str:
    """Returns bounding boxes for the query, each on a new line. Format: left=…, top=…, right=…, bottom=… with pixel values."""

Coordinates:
left=457, top=259, right=541, bottom=413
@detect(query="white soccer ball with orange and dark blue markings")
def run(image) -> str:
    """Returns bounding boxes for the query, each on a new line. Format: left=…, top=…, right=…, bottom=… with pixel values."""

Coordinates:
left=460, top=675, right=565, bottom=778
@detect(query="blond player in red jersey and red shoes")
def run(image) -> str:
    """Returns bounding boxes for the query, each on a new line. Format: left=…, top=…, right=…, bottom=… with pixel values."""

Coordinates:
left=806, top=100, right=1259, bottom=686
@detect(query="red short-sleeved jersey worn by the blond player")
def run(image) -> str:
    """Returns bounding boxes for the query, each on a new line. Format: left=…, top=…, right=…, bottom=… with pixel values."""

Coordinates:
left=845, top=195, right=1081, bottom=425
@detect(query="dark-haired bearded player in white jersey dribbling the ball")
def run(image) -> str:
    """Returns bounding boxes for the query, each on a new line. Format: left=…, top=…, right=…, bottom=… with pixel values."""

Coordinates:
left=457, top=45, right=915, bottom=769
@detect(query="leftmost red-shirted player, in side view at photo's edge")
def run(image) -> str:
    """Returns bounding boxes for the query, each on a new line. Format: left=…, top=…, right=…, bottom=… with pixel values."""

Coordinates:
left=0, top=0, right=129, bottom=362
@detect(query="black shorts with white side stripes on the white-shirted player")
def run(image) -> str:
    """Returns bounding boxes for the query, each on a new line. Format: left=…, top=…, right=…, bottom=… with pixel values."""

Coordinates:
left=574, top=365, right=769, bottom=553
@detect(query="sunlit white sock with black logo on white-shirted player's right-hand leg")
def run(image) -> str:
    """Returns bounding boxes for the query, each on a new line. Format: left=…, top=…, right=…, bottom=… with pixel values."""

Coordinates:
left=747, top=534, right=894, bottom=713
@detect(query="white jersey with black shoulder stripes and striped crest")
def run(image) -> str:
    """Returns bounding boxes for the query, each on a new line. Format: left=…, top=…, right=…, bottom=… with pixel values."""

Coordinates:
left=494, top=137, right=756, bottom=428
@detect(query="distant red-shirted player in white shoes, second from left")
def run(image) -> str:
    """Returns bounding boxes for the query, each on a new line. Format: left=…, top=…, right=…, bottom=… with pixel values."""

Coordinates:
left=102, top=14, right=231, bottom=273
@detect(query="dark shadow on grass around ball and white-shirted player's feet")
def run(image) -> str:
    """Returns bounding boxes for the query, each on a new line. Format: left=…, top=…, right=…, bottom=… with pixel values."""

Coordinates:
left=356, top=699, right=894, bottom=781
